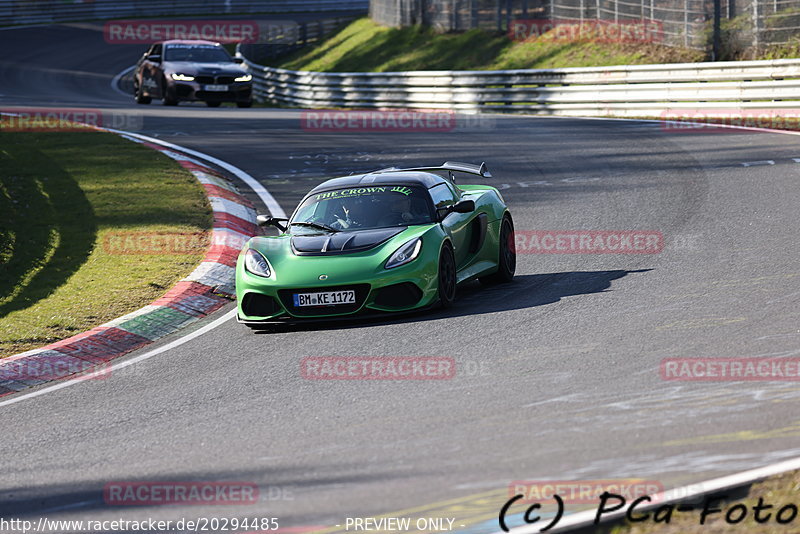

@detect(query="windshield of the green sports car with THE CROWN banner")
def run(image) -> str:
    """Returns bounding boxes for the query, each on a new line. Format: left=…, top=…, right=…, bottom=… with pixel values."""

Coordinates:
left=291, top=185, right=434, bottom=232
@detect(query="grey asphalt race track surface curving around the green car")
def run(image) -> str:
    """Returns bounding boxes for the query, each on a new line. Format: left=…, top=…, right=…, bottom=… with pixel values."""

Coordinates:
left=0, top=18, right=800, bottom=531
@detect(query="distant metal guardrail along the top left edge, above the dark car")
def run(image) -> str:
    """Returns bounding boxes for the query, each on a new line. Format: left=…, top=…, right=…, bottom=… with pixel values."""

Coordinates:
left=0, top=0, right=369, bottom=26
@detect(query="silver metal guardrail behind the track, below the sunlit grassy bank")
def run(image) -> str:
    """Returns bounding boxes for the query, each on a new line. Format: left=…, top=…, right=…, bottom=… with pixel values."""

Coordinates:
left=239, top=58, right=800, bottom=117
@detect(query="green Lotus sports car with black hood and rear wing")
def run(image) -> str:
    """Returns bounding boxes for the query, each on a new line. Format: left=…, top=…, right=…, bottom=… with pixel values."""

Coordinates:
left=236, top=162, right=516, bottom=328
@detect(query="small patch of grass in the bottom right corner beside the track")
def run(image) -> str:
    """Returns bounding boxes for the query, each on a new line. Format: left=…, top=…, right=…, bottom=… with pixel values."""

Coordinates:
left=607, top=471, right=800, bottom=534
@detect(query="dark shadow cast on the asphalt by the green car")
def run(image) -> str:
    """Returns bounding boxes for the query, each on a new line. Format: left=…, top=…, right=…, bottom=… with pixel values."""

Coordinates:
left=256, top=269, right=652, bottom=334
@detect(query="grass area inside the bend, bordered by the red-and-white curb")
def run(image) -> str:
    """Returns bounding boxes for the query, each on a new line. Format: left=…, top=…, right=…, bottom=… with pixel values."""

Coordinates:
left=0, top=131, right=211, bottom=357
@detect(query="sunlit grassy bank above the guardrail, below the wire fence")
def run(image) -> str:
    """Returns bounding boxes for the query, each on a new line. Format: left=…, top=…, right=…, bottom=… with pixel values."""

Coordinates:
left=274, top=18, right=704, bottom=72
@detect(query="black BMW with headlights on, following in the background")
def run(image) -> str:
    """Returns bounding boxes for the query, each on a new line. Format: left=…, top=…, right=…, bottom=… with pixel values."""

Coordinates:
left=133, top=40, right=253, bottom=108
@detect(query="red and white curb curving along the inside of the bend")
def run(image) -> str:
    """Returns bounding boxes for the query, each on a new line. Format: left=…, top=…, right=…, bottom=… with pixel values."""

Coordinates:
left=0, top=130, right=268, bottom=397
